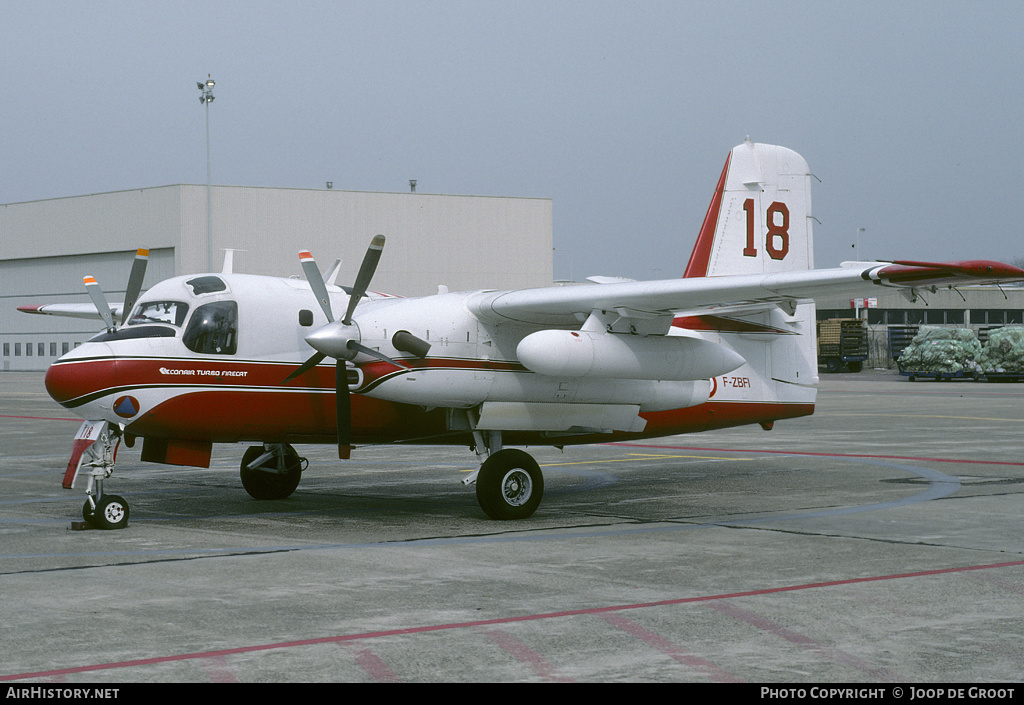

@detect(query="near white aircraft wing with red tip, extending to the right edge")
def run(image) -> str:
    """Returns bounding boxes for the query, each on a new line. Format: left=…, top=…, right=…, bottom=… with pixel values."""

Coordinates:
left=469, top=260, right=1024, bottom=326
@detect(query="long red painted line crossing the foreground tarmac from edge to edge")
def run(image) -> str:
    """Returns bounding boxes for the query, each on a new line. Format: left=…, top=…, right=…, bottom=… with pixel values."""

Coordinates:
left=0, top=561, right=1024, bottom=681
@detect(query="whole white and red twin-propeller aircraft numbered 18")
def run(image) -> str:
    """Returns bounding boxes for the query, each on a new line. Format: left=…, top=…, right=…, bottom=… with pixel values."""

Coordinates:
left=22, top=140, right=1024, bottom=529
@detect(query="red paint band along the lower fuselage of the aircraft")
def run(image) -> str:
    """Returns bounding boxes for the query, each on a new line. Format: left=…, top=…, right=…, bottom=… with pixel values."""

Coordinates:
left=46, top=358, right=814, bottom=445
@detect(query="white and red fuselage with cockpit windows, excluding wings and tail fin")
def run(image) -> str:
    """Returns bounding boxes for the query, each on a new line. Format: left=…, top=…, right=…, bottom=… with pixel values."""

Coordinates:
left=46, top=274, right=813, bottom=459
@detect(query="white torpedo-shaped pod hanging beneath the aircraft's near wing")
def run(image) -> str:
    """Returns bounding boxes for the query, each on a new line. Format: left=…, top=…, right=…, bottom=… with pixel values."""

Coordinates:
left=516, top=330, right=746, bottom=381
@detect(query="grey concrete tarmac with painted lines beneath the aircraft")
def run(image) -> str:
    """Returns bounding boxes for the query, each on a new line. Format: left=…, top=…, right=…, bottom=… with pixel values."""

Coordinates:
left=0, top=372, right=1024, bottom=683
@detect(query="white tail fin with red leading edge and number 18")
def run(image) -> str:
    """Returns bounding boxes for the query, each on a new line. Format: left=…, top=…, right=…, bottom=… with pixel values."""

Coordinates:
left=683, top=139, right=814, bottom=277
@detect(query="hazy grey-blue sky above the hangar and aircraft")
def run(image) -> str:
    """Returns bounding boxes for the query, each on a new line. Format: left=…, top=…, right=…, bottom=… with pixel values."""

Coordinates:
left=0, top=0, right=1024, bottom=282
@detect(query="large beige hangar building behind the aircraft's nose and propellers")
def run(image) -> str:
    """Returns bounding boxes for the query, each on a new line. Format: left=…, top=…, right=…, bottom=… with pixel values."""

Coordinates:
left=0, top=184, right=553, bottom=370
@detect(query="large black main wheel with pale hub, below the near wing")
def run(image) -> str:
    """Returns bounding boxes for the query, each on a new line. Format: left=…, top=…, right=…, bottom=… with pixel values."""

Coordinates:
left=476, top=448, right=544, bottom=520
